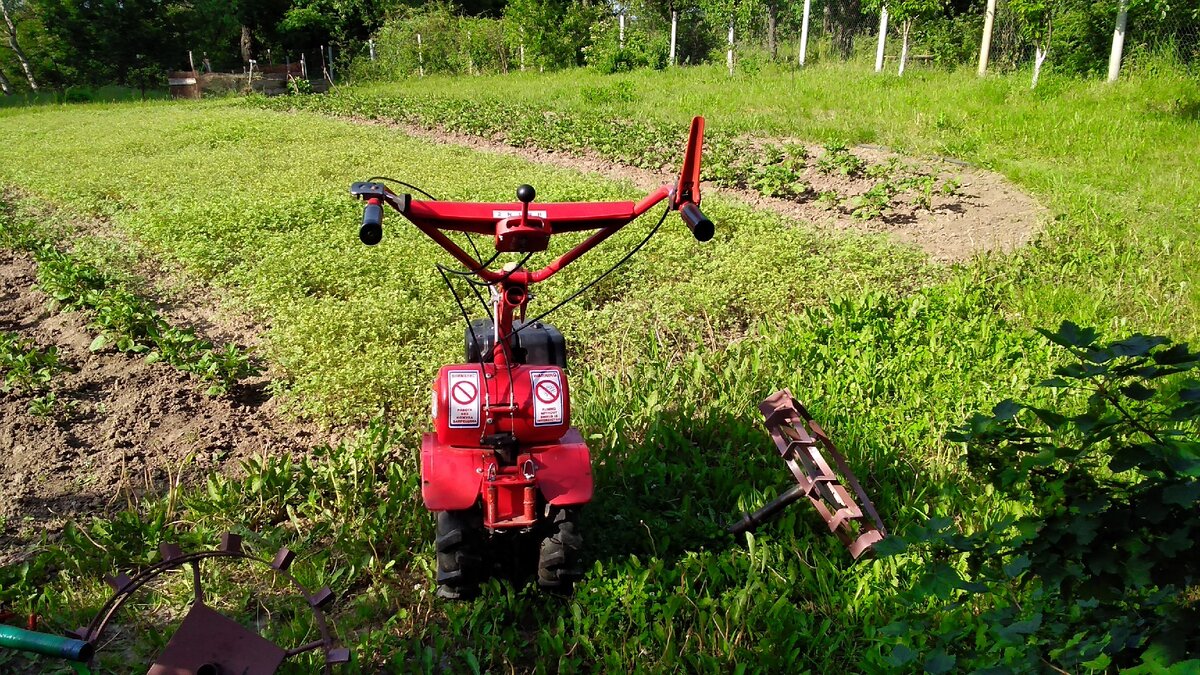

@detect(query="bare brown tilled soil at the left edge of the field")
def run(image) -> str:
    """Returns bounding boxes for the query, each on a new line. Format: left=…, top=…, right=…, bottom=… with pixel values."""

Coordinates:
left=0, top=251, right=326, bottom=566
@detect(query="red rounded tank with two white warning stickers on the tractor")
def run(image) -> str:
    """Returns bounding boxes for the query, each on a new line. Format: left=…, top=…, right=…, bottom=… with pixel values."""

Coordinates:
left=433, top=363, right=571, bottom=448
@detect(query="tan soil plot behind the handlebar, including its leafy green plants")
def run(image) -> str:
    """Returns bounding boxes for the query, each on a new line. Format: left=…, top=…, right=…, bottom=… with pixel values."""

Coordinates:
left=379, top=118, right=1046, bottom=263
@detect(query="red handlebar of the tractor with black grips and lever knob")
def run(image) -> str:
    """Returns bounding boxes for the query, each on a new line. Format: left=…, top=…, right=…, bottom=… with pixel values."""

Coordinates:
left=350, top=117, right=714, bottom=283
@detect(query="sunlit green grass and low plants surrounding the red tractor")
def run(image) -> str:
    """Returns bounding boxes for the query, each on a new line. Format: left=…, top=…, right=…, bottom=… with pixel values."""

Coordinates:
left=0, top=60, right=1200, bottom=673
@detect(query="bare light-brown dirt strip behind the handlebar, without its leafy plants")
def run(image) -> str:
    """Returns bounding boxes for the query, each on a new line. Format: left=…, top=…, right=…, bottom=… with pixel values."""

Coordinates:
left=343, top=118, right=1045, bottom=263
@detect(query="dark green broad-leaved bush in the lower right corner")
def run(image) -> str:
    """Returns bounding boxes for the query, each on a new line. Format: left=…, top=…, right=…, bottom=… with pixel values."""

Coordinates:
left=882, top=322, right=1200, bottom=673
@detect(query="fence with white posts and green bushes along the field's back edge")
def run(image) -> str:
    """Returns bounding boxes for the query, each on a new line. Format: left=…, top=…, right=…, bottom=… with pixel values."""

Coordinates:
left=292, top=0, right=1200, bottom=79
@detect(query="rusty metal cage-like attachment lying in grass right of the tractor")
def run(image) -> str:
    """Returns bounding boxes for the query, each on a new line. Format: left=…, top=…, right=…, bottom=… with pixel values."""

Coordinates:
left=730, top=389, right=887, bottom=560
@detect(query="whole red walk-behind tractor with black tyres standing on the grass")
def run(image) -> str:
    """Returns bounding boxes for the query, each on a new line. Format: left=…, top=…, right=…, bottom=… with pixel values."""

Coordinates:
left=350, top=118, right=714, bottom=598
